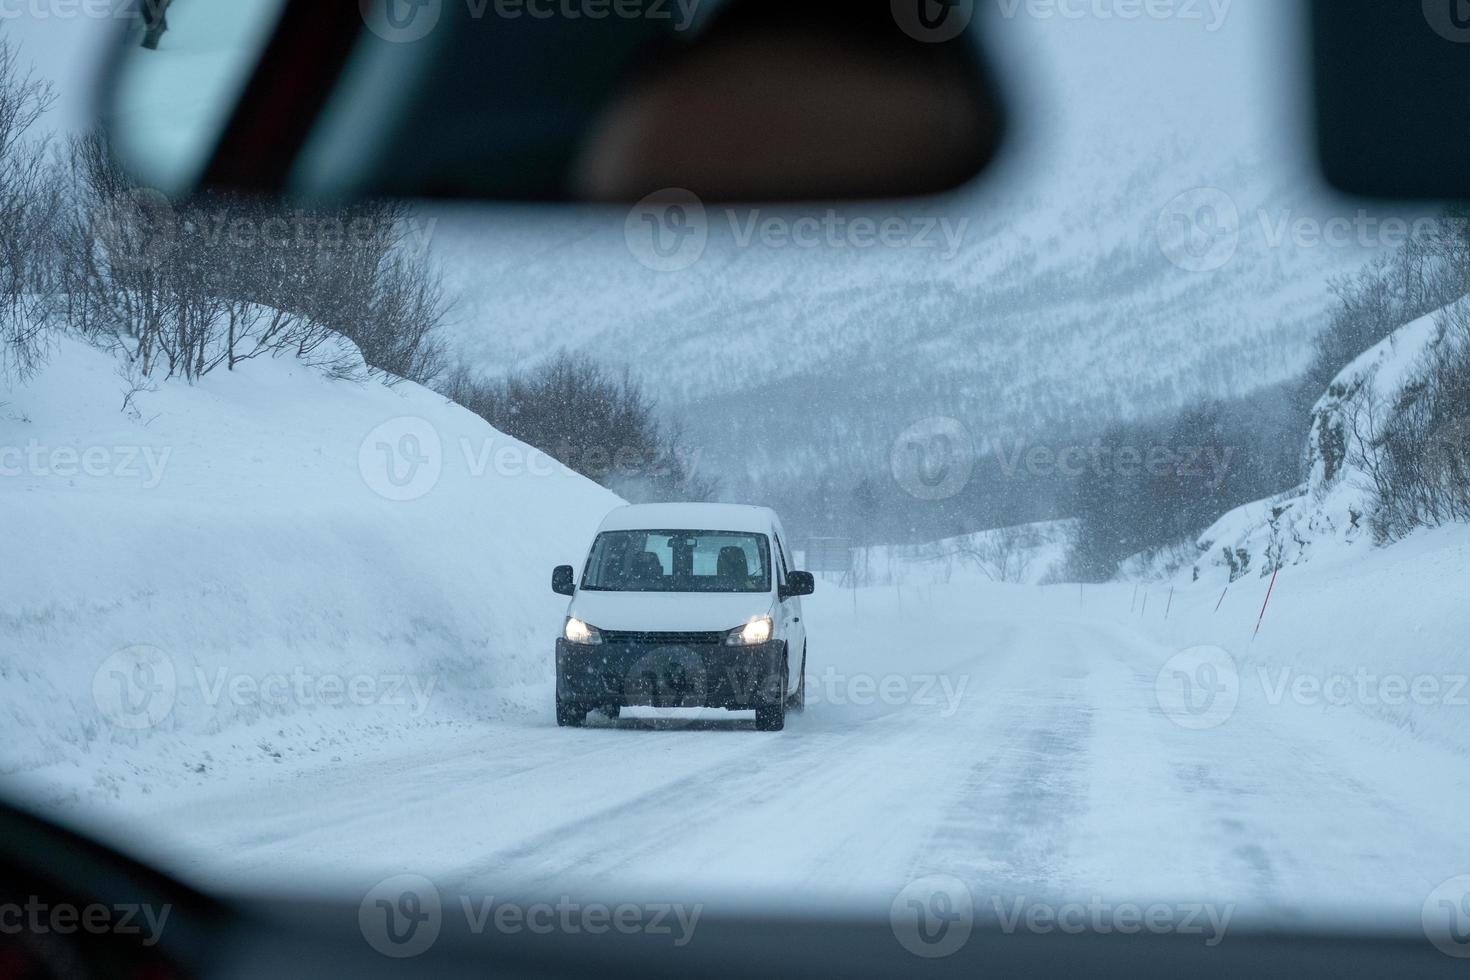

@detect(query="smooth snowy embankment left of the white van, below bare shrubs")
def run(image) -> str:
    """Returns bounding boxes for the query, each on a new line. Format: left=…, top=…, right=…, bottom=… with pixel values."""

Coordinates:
left=0, top=341, right=620, bottom=802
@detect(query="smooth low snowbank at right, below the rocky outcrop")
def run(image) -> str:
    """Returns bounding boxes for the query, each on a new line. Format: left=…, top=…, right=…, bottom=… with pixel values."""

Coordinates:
left=1105, top=526, right=1470, bottom=764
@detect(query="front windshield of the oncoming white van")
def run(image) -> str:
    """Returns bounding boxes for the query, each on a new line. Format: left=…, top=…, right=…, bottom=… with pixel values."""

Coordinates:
left=582, top=530, right=770, bottom=592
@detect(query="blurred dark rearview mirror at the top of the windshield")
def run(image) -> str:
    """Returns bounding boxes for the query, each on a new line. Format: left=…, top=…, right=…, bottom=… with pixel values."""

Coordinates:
left=101, top=0, right=1001, bottom=203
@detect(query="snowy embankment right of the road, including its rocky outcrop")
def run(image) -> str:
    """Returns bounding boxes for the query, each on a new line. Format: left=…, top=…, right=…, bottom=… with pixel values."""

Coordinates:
left=1113, top=299, right=1470, bottom=755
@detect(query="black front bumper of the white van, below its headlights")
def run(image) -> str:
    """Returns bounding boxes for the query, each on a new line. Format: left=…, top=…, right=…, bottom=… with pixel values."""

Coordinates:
left=556, top=635, right=786, bottom=711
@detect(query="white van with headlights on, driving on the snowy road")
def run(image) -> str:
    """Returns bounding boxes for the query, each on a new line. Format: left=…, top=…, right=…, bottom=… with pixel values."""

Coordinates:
left=551, top=504, right=816, bottom=732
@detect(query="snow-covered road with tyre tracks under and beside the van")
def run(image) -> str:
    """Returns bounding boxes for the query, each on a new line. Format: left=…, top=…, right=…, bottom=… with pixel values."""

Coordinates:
left=97, top=586, right=1470, bottom=924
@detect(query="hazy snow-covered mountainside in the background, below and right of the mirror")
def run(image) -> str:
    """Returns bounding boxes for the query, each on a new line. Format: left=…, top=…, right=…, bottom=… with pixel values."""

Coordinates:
left=432, top=3, right=1385, bottom=492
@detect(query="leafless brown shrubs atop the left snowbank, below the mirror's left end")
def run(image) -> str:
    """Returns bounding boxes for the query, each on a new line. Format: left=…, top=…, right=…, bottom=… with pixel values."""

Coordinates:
left=55, top=135, right=448, bottom=382
